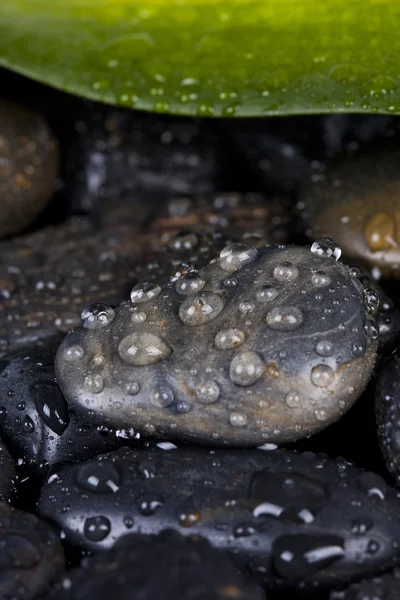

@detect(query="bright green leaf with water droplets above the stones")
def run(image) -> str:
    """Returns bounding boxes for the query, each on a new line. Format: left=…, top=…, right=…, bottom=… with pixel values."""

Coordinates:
left=0, top=0, right=400, bottom=116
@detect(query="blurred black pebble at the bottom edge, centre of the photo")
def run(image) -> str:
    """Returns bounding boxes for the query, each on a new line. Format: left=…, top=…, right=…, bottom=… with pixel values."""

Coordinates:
left=49, top=531, right=265, bottom=600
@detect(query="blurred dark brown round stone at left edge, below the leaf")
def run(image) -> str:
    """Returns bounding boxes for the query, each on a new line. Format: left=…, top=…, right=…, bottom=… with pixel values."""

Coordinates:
left=0, top=99, right=58, bottom=238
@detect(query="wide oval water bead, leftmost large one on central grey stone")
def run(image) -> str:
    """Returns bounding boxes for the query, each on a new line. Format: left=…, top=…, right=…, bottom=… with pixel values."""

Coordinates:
left=118, top=332, right=172, bottom=367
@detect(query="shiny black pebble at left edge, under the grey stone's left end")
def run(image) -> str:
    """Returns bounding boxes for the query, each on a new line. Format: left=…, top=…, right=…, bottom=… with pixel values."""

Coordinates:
left=0, top=349, right=127, bottom=470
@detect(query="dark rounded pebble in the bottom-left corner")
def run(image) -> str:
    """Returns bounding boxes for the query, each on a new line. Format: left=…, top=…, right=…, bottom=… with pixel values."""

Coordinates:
left=0, top=503, right=64, bottom=600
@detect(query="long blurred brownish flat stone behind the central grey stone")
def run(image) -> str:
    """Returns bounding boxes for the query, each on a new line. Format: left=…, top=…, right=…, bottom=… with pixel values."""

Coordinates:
left=0, top=193, right=288, bottom=356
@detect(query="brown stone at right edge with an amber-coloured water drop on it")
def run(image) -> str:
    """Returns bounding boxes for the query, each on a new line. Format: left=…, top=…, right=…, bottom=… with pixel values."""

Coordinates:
left=299, top=142, right=400, bottom=279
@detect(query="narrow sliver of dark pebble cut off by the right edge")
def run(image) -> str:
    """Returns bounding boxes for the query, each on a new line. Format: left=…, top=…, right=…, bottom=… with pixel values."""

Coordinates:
left=375, top=355, right=400, bottom=485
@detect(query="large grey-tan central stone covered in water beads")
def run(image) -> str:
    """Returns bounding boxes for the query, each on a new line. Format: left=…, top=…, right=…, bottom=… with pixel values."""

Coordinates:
left=56, top=241, right=378, bottom=446
